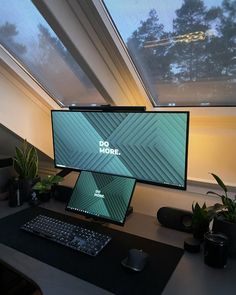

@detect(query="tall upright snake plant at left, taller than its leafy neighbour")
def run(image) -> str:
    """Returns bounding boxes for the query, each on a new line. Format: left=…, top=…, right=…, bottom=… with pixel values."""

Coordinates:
left=13, top=139, right=38, bottom=201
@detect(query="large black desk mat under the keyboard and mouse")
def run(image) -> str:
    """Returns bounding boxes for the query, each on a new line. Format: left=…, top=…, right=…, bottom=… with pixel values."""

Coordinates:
left=0, top=207, right=183, bottom=295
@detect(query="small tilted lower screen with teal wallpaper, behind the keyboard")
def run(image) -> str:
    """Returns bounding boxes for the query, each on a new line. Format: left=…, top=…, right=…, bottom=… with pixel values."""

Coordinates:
left=66, top=171, right=136, bottom=225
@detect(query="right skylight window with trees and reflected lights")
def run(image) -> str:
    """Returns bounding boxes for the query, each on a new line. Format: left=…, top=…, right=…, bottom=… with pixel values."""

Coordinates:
left=103, top=0, right=236, bottom=106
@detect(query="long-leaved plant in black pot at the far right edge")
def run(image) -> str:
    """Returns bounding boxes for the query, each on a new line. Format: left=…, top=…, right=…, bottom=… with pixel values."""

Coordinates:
left=207, top=173, right=236, bottom=258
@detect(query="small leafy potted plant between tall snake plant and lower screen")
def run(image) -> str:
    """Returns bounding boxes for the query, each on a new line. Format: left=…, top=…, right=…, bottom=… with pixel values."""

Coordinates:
left=33, top=175, right=63, bottom=202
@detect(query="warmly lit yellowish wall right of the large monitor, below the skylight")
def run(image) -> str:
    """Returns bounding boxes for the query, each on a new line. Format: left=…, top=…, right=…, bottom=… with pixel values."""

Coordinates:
left=188, top=114, right=236, bottom=187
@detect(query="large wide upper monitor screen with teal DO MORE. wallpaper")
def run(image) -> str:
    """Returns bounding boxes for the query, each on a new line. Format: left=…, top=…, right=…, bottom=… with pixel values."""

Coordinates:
left=52, top=111, right=189, bottom=189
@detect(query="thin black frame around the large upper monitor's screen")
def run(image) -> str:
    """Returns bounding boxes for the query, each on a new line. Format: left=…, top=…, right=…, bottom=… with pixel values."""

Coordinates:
left=51, top=110, right=190, bottom=191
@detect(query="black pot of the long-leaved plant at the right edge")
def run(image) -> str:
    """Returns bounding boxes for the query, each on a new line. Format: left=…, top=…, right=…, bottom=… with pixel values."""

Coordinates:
left=212, top=216, right=236, bottom=258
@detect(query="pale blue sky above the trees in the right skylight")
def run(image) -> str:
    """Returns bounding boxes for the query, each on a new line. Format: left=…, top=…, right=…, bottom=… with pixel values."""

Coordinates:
left=104, top=0, right=222, bottom=41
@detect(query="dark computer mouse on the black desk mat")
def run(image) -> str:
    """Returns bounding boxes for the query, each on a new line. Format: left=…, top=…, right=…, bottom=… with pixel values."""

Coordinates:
left=121, top=249, right=149, bottom=271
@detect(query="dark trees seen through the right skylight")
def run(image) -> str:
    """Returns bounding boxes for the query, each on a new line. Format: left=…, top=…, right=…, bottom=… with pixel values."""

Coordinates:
left=127, top=0, right=236, bottom=83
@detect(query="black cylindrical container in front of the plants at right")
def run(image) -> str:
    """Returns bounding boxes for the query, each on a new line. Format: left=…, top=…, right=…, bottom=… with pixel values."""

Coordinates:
left=204, top=232, right=228, bottom=268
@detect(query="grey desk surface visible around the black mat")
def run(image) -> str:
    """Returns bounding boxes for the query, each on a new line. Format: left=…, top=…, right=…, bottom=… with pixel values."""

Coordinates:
left=0, top=201, right=236, bottom=295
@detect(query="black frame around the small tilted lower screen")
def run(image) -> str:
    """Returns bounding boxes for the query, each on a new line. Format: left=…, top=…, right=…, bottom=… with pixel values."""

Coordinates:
left=65, top=170, right=137, bottom=226
